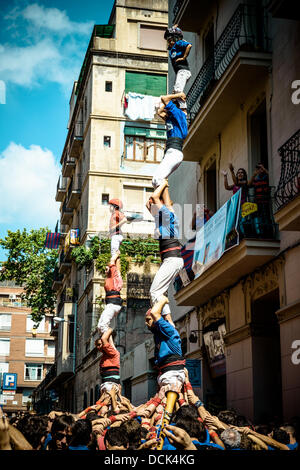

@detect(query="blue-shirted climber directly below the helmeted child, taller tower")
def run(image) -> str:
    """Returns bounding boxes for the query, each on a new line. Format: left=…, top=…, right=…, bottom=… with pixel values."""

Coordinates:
left=152, top=93, right=188, bottom=188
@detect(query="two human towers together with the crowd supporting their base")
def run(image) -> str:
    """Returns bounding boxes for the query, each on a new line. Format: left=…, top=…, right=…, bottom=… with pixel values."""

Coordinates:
left=0, top=25, right=299, bottom=450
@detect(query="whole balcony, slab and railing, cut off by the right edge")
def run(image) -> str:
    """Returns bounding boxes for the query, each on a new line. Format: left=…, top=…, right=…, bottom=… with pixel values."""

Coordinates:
left=275, top=129, right=300, bottom=231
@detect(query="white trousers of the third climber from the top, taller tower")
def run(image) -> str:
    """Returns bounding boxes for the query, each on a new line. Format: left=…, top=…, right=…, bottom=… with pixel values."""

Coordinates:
left=150, top=256, right=184, bottom=315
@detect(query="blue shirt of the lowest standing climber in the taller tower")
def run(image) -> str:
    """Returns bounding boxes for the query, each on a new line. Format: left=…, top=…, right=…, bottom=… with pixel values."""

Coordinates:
left=153, top=317, right=182, bottom=365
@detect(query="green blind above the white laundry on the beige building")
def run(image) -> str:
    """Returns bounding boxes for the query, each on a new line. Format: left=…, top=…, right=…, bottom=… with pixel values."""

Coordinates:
left=125, top=72, right=167, bottom=96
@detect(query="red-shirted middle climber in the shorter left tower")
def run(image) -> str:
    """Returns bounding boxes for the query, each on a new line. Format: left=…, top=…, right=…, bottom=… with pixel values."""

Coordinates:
left=97, top=251, right=123, bottom=335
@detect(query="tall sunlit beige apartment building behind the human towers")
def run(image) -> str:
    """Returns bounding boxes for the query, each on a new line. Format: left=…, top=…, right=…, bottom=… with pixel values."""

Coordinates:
left=37, top=0, right=168, bottom=412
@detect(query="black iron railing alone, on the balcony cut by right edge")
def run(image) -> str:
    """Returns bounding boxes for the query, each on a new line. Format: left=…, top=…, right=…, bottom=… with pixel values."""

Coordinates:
left=275, top=129, right=300, bottom=211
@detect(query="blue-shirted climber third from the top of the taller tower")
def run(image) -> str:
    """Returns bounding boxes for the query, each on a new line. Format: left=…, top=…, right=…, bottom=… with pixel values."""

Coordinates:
left=146, top=180, right=184, bottom=326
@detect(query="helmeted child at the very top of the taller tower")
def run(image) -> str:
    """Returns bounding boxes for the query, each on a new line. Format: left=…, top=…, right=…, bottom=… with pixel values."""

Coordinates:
left=164, top=24, right=192, bottom=109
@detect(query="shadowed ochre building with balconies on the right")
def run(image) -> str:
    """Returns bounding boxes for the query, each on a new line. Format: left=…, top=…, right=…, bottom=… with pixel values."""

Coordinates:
left=120, top=0, right=300, bottom=423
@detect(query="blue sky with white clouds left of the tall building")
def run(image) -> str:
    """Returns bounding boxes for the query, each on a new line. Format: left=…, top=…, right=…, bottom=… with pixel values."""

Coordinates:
left=0, top=0, right=114, bottom=261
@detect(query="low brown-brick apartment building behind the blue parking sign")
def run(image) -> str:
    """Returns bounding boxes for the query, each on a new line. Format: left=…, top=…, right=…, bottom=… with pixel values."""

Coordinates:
left=0, top=281, right=55, bottom=415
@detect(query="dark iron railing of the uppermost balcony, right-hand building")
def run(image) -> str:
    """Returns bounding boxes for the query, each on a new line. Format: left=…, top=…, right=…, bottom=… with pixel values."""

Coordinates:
left=187, top=4, right=270, bottom=124
